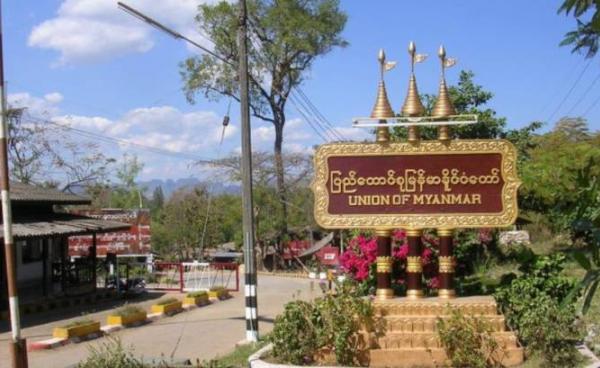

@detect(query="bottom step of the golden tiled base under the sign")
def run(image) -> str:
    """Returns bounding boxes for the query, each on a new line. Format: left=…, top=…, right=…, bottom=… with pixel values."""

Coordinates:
left=369, top=347, right=524, bottom=368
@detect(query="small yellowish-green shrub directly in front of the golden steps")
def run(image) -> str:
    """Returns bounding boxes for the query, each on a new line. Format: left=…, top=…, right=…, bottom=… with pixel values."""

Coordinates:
left=437, top=309, right=502, bottom=368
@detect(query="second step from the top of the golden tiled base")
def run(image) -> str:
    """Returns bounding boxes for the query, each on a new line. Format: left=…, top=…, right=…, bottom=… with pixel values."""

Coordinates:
left=383, top=315, right=506, bottom=332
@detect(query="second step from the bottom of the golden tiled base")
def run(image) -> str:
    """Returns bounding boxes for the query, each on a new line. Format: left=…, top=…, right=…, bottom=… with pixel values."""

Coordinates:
left=377, top=332, right=518, bottom=349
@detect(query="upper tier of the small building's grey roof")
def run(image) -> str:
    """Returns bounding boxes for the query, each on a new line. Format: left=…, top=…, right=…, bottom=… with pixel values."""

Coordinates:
left=10, top=182, right=92, bottom=204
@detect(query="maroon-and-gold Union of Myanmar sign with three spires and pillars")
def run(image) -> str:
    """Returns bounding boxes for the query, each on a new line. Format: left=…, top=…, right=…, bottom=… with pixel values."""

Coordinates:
left=312, top=42, right=521, bottom=299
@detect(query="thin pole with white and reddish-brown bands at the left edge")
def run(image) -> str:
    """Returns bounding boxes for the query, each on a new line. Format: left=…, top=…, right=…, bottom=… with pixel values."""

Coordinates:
left=0, top=0, right=27, bottom=368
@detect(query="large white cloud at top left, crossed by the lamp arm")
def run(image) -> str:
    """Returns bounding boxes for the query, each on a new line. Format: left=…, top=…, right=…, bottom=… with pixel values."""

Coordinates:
left=28, top=0, right=219, bottom=65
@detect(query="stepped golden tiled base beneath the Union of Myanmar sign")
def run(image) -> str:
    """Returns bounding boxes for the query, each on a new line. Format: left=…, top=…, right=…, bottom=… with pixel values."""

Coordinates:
left=370, top=296, right=523, bottom=367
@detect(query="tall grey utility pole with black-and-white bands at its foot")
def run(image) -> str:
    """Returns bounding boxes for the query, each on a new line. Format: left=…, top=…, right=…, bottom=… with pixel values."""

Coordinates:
left=238, top=0, right=258, bottom=342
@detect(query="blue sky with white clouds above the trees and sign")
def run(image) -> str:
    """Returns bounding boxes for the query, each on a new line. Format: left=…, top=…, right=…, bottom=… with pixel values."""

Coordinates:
left=3, top=0, right=600, bottom=179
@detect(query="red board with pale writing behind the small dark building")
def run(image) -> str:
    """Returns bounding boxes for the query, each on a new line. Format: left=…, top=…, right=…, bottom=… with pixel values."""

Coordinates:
left=69, top=209, right=151, bottom=256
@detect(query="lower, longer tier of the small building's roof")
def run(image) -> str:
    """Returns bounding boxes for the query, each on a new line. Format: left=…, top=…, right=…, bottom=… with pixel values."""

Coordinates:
left=0, top=213, right=131, bottom=239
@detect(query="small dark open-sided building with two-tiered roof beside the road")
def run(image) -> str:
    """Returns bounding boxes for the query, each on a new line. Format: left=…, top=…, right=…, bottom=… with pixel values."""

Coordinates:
left=0, top=182, right=130, bottom=310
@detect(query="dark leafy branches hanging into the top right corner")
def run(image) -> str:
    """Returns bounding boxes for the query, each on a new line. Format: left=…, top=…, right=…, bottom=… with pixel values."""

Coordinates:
left=558, top=0, right=600, bottom=58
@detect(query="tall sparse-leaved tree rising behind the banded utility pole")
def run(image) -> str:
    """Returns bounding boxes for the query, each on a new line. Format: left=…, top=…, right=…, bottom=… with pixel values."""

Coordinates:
left=181, top=0, right=347, bottom=233
